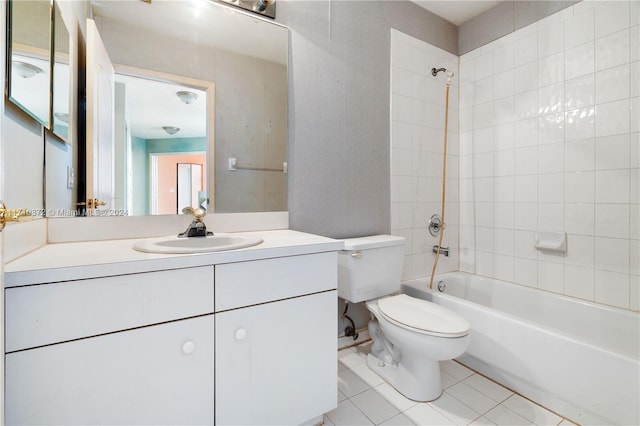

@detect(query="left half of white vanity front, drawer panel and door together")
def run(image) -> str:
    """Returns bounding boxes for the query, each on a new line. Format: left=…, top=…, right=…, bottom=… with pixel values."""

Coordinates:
left=5, top=266, right=214, bottom=425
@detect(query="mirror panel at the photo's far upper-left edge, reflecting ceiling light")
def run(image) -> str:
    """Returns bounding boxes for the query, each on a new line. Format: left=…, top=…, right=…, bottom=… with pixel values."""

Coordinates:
left=7, top=0, right=52, bottom=128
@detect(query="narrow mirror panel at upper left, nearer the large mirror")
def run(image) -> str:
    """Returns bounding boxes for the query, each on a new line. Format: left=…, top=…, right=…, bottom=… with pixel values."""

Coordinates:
left=52, top=2, right=71, bottom=141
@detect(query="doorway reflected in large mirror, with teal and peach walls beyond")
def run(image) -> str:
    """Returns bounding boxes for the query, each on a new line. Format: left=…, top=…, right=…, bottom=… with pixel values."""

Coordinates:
left=114, top=72, right=214, bottom=215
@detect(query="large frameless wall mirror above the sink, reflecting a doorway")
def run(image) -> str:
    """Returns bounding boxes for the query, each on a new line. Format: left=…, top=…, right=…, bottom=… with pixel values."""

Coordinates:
left=79, top=0, right=288, bottom=215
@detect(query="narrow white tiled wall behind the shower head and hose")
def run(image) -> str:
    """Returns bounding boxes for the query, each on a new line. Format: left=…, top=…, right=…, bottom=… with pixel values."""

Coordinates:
left=391, top=30, right=458, bottom=280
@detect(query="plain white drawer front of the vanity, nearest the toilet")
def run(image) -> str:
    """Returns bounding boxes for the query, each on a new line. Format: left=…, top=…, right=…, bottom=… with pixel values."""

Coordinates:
left=216, top=252, right=338, bottom=312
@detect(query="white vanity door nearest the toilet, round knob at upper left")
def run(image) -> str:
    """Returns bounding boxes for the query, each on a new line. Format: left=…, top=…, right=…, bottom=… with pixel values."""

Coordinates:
left=215, top=291, right=338, bottom=425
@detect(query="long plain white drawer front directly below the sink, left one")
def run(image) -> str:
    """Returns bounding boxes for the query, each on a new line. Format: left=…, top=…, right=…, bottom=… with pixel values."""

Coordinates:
left=5, top=266, right=214, bottom=352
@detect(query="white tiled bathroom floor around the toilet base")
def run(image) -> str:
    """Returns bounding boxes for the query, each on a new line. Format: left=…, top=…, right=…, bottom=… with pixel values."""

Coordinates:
left=324, top=343, right=573, bottom=426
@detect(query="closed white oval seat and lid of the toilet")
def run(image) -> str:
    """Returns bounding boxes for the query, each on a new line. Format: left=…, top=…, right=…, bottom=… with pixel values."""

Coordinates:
left=378, top=294, right=470, bottom=337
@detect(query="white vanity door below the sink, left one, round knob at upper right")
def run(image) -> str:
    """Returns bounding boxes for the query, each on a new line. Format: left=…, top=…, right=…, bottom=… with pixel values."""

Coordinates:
left=5, top=315, right=214, bottom=425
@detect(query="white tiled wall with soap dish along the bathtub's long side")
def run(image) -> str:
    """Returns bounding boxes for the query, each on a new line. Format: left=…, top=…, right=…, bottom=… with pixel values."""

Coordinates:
left=459, top=0, right=640, bottom=310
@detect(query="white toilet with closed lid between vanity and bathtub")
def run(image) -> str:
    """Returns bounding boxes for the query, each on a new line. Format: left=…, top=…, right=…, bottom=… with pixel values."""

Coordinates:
left=338, top=235, right=469, bottom=401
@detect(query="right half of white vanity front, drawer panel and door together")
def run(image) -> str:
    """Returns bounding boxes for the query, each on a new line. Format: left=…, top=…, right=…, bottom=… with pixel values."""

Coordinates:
left=215, top=252, right=338, bottom=425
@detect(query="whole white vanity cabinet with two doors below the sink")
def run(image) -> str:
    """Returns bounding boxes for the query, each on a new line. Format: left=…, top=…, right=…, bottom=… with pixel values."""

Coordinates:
left=4, top=235, right=341, bottom=426
